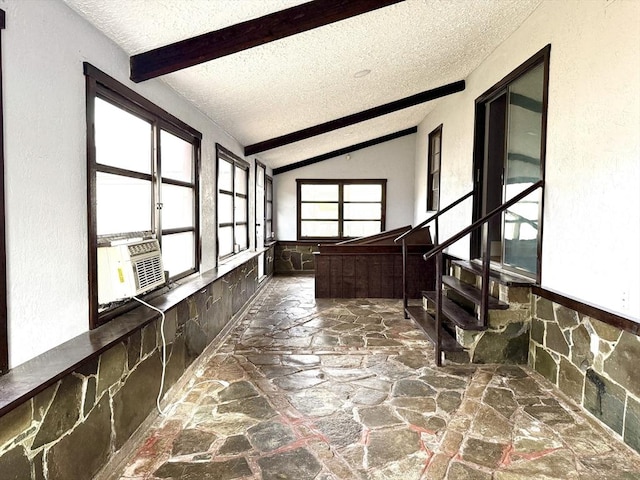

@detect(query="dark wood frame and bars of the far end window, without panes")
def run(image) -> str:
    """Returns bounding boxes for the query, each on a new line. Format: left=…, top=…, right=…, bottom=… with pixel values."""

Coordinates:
left=296, top=178, right=387, bottom=241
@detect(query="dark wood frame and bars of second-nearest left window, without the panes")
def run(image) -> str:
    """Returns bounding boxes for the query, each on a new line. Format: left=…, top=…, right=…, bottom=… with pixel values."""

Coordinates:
left=216, top=143, right=250, bottom=261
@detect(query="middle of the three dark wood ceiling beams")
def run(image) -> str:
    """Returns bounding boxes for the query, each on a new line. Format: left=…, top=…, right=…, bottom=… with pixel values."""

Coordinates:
left=244, top=80, right=465, bottom=156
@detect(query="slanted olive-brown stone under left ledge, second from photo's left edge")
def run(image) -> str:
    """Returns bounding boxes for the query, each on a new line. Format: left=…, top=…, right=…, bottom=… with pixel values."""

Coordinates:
left=32, top=375, right=82, bottom=449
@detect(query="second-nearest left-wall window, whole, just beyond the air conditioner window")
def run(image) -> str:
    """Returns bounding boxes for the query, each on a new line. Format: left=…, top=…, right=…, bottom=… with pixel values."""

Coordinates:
left=216, top=144, right=249, bottom=260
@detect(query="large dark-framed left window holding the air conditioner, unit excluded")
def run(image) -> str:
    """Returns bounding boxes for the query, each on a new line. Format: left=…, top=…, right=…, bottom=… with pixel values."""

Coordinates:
left=85, top=64, right=202, bottom=328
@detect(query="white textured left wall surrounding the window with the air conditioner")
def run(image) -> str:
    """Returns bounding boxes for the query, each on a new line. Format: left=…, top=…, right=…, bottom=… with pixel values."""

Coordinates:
left=0, top=0, right=246, bottom=367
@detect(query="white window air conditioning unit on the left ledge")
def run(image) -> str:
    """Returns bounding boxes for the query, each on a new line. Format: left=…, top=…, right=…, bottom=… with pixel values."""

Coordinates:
left=98, top=240, right=166, bottom=305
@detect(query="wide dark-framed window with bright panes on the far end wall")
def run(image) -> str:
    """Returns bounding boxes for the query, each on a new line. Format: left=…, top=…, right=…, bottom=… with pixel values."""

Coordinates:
left=296, top=180, right=387, bottom=240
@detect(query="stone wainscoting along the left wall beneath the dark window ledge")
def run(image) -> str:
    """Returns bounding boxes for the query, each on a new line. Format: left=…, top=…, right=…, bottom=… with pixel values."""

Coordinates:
left=0, top=257, right=258, bottom=480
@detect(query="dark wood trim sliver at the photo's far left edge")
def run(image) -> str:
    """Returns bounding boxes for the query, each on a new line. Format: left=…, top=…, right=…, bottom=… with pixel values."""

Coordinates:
left=0, top=10, right=9, bottom=375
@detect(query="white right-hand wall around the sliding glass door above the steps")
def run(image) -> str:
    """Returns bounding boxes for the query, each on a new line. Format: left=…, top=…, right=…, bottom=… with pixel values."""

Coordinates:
left=414, top=0, right=640, bottom=319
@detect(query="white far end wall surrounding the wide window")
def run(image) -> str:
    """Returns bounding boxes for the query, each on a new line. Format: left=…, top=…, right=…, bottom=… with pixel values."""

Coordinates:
left=273, top=134, right=416, bottom=240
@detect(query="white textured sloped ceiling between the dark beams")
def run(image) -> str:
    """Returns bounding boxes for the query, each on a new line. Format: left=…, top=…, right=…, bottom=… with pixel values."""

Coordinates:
left=63, top=0, right=541, bottom=168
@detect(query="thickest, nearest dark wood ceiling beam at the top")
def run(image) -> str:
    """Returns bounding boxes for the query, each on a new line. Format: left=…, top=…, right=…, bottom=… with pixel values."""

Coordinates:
left=130, top=0, right=404, bottom=82
